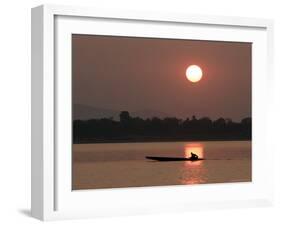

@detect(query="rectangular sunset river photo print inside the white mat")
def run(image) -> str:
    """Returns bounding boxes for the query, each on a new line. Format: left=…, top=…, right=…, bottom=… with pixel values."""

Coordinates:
left=72, top=34, right=252, bottom=190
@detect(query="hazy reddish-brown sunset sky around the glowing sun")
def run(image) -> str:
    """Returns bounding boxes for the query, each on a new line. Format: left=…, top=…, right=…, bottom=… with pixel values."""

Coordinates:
left=72, top=35, right=251, bottom=121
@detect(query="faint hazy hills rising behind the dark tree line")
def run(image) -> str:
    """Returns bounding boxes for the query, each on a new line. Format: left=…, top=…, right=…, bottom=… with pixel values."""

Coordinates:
left=73, top=104, right=170, bottom=120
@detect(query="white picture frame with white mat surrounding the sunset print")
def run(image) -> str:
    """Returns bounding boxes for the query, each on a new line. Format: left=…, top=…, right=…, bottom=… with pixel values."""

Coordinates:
left=31, top=5, right=273, bottom=220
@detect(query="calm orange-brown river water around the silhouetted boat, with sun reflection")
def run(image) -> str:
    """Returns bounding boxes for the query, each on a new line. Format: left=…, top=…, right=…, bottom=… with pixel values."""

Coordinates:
left=72, top=141, right=251, bottom=189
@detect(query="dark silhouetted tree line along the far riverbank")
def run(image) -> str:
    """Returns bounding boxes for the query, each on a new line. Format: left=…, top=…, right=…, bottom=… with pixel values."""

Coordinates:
left=73, top=111, right=249, bottom=143
